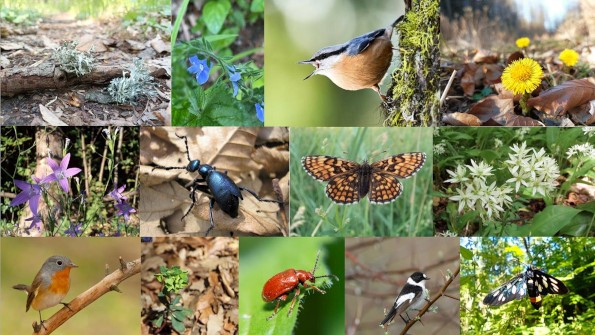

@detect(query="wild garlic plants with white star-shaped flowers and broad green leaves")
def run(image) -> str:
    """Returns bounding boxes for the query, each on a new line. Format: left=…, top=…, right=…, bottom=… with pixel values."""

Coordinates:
left=434, top=127, right=595, bottom=236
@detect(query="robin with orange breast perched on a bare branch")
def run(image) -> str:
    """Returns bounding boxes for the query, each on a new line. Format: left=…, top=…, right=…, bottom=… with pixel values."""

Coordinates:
left=12, top=256, right=78, bottom=328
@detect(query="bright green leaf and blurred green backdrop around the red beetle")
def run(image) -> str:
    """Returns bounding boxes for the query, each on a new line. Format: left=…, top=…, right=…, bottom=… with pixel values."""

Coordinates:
left=239, top=237, right=345, bottom=335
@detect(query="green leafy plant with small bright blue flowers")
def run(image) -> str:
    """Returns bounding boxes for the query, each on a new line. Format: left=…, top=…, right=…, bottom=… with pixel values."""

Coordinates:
left=172, top=0, right=264, bottom=126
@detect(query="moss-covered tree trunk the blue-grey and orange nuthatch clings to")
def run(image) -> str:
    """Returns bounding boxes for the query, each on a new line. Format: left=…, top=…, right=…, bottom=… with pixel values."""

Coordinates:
left=384, top=0, right=440, bottom=127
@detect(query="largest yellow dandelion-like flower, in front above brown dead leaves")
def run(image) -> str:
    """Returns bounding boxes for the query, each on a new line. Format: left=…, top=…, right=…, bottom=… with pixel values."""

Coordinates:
left=502, top=58, right=543, bottom=94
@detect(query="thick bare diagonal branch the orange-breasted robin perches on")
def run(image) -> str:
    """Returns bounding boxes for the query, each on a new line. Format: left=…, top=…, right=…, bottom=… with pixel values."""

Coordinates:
left=33, top=257, right=141, bottom=335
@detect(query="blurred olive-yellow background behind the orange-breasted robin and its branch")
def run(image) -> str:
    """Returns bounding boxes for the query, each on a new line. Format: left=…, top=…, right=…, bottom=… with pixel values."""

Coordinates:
left=0, top=237, right=140, bottom=335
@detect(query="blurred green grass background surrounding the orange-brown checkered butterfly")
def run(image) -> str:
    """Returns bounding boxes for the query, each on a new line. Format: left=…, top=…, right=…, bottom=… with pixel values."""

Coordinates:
left=290, top=127, right=433, bottom=237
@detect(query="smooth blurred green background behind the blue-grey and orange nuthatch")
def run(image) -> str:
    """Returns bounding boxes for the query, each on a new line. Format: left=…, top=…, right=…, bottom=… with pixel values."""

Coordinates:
left=265, top=0, right=405, bottom=126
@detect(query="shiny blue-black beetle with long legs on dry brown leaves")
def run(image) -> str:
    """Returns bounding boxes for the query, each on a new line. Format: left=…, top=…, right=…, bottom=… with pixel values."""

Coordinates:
left=153, top=134, right=283, bottom=236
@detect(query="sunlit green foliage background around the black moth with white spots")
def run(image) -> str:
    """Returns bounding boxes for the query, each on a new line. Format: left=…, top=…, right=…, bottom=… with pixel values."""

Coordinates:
left=461, top=238, right=595, bottom=335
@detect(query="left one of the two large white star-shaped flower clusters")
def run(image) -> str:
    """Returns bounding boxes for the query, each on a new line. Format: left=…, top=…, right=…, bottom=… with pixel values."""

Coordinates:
left=445, top=160, right=512, bottom=220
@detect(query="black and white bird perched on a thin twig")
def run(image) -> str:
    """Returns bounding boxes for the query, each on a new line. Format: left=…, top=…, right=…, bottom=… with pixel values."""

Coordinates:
left=380, top=272, right=430, bottom=326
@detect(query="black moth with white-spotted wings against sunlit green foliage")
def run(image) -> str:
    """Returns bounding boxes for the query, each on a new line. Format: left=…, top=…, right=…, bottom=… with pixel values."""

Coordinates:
left=483, top=266, right=568, bottom=309
